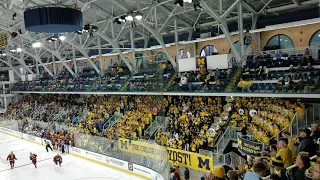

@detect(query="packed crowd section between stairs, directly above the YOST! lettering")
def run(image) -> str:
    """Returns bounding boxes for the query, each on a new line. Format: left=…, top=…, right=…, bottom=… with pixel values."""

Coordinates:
left=156, top=96, right=228, bottom=152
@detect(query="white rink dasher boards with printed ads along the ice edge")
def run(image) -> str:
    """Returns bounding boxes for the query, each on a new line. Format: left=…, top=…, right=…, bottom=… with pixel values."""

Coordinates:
left=0, top=127, right=164, bottom=180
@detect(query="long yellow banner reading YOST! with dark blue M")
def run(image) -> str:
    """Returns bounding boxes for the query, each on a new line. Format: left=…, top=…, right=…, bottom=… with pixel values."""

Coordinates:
left=118, top=138, right=214, bottom=173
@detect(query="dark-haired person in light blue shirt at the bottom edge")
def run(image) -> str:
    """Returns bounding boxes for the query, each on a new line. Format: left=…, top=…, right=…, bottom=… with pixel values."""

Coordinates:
left=244, top=161, right=268, bottom=180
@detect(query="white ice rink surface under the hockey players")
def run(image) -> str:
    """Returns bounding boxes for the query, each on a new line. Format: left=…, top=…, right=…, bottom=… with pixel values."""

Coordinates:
left=0, top=133, right=142, bottom=180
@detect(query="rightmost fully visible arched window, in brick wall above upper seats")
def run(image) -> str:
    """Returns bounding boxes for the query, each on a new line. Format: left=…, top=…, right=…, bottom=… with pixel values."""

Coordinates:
left=266, top=34, right=294, bottom=49
